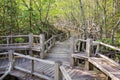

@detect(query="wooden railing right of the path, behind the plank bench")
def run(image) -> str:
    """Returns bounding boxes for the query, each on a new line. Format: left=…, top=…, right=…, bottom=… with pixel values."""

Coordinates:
left=73, top=39, right=120, bottom=56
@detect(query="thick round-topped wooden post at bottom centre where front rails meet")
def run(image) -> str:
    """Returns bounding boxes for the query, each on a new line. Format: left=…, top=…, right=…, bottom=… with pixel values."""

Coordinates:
left=54, top=61, right=62, bottom=80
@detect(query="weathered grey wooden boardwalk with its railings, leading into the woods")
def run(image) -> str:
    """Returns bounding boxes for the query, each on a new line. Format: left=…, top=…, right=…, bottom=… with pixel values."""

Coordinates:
left=0, top=33, right=120, bottom=80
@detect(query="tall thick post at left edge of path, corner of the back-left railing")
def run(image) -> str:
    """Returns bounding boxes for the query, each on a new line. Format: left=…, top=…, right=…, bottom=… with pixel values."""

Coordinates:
left=39, top=34, right=45, bottom=59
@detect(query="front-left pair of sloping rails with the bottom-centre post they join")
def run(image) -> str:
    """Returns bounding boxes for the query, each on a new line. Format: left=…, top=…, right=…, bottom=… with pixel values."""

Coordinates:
left=14, top=53, right=60, bottom=80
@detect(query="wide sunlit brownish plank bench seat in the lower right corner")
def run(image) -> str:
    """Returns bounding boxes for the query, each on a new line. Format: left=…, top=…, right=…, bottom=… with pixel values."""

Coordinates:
left=88, top=57, right=120, bottom=80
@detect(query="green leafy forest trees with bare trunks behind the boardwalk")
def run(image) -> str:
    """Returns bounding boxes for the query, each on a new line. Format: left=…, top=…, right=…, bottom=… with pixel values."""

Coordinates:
left=0, top=0, right=120, bottom=43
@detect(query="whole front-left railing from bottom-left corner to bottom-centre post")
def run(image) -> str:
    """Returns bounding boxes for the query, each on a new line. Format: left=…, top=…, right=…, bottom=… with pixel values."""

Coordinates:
left=0, top=50, right=61, bottom=80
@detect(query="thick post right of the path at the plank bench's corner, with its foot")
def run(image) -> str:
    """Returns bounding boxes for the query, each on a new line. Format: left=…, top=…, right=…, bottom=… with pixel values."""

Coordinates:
left=85, top=39, right=92, bottom=70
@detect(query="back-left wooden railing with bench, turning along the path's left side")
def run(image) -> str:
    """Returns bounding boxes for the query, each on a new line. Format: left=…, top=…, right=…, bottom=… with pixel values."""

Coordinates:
left=0, top=33, right=66, bottom=58
